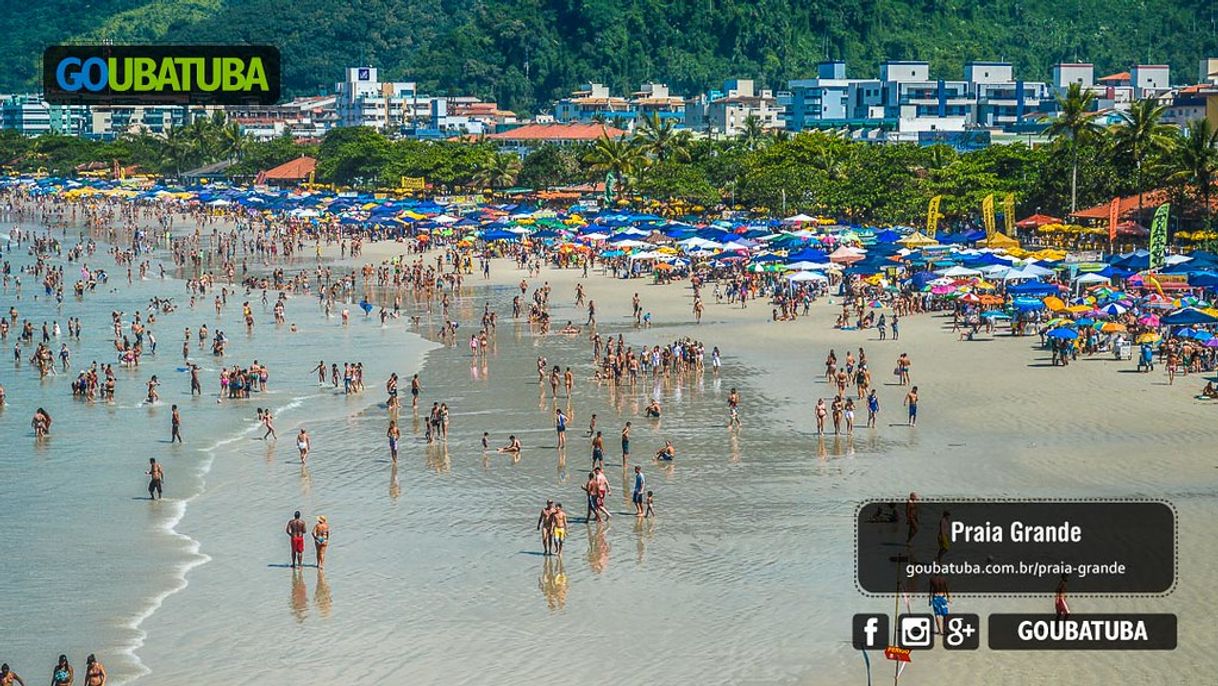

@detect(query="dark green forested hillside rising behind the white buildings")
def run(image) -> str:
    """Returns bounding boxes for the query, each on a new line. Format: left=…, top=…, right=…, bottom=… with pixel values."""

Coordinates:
left=7, top=0, right=1218, bottom=113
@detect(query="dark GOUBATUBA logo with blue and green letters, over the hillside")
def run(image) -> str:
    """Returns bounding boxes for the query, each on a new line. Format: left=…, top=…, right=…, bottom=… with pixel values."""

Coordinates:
left=43, top=45, right=280, bottom=105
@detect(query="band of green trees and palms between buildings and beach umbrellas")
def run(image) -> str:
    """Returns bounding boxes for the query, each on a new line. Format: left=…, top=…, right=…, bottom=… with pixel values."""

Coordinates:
left=0, top=101, right=1218, bottom=228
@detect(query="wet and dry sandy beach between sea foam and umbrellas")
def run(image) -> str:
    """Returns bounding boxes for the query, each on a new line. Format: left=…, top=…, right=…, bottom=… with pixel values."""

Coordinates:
left=2, top=210, right=1218, bottom=684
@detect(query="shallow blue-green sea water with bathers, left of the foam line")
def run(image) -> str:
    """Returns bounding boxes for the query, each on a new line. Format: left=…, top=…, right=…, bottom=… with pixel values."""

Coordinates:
left=0, top=224, right=429, bottom=684
